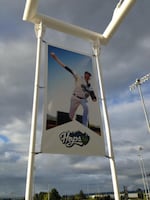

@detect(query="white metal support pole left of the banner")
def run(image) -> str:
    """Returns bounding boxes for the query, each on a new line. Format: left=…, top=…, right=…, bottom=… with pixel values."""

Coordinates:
left=25, top=23, right=43, bottom=200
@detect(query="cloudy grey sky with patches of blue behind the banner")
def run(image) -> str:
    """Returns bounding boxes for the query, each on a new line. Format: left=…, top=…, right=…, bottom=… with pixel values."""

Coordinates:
left=0, top=0, right=150, bottom=196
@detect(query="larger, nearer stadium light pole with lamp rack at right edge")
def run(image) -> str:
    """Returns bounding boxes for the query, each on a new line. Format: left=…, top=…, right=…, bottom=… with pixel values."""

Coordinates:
left=129, top=73, right=150, bottom=133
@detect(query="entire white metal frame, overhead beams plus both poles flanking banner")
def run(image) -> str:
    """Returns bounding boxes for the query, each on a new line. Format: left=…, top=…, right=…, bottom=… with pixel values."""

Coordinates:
left=23, top=0, right=136, bottom=200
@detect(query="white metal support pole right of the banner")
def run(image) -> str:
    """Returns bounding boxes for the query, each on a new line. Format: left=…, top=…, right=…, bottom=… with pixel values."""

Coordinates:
left=93, top=41, right=120, bottom=200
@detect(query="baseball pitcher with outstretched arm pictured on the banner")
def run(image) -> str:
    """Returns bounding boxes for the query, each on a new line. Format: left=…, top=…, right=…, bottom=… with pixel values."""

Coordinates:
left=50, top=52, right=97, bottom=126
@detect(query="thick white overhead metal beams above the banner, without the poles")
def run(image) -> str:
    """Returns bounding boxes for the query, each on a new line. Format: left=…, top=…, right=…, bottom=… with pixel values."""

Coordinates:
left=23, top=0, right=136, bottom=44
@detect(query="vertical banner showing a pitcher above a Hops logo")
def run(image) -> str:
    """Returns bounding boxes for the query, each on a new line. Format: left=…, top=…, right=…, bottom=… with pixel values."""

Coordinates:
left=41, top=45, right=105, bottom=156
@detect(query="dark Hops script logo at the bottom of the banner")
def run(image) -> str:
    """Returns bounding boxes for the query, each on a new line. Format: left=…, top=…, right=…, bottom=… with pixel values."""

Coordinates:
left=59, top=131, right=90, bottom=147
